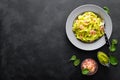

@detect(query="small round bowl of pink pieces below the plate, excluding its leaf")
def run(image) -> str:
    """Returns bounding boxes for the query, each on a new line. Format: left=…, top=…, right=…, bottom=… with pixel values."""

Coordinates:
left=81, top=58, right=98, bottom=75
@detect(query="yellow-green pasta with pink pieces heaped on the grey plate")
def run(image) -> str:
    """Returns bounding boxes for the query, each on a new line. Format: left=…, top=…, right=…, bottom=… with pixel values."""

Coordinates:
left=72, top=11, right=104, bottom=43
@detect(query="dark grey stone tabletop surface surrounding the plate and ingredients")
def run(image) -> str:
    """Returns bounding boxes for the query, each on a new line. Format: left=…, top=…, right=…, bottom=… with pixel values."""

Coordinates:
left=0, top=0, right=120, bottom=80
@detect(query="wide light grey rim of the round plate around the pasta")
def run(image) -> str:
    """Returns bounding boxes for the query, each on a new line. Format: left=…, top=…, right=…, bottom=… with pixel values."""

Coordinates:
left=66, top=4, right=112, bottom=51
